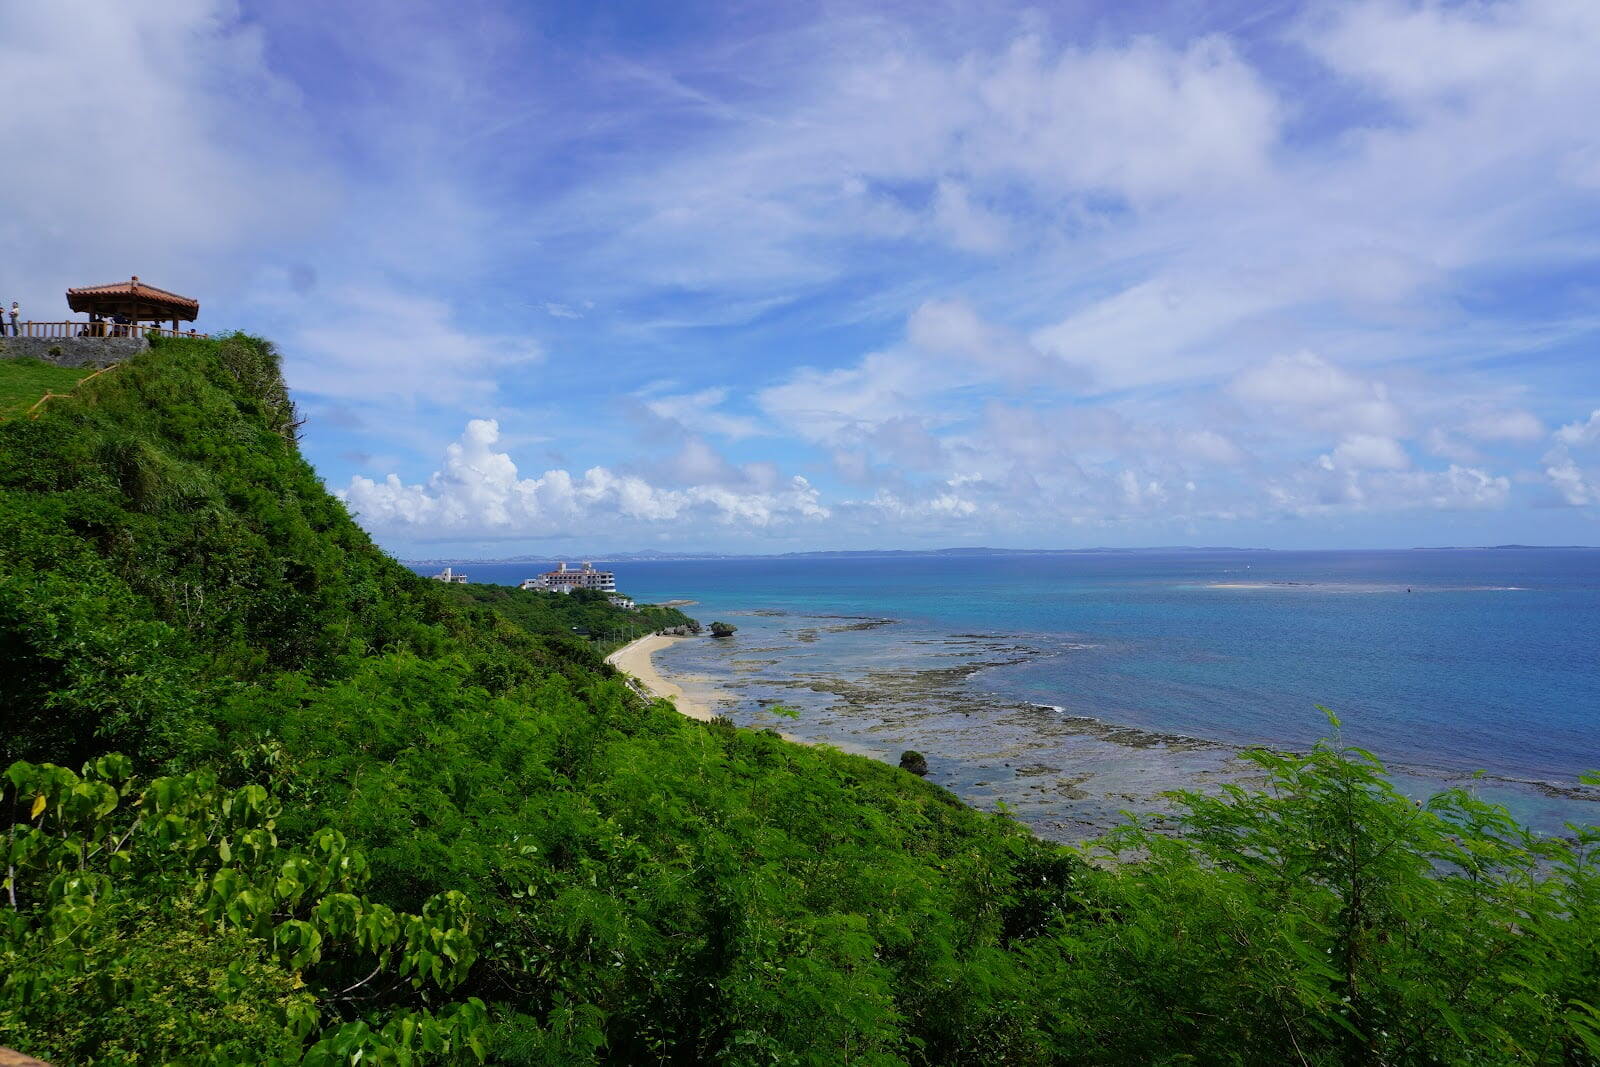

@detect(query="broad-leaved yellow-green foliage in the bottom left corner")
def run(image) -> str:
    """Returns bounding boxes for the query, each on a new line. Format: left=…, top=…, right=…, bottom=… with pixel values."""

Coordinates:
left=0, top=755, right=488, bottom=1064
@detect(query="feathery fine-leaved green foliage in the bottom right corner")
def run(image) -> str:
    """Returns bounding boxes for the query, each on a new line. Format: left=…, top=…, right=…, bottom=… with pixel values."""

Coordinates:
left=1029, top=742, right=1600, bottom=1064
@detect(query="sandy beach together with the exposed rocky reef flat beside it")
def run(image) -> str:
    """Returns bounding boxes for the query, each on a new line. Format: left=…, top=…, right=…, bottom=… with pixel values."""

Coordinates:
left=606, top=611, right=1600, bottom=841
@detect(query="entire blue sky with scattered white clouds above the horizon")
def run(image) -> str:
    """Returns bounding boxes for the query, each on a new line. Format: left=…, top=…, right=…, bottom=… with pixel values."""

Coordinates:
left=0, top=0, right=1600, bottom=557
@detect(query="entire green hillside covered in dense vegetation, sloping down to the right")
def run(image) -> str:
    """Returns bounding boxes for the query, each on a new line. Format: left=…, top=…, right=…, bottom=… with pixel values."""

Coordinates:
left=0, top=336, right=1600, bottom=1064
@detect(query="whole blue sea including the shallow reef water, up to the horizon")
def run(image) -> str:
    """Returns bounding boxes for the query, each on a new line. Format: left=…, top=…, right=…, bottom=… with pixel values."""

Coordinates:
left=418, top=549, right=1600, bottom=837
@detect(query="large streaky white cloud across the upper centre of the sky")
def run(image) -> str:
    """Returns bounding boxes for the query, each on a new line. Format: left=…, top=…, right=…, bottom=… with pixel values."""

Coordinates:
left=549, top=28, right=1282, bottom=293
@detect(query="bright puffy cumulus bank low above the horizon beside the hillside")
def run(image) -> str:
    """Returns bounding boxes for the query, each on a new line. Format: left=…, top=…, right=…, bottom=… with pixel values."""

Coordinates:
left=339, top=419, right=829, bottom=537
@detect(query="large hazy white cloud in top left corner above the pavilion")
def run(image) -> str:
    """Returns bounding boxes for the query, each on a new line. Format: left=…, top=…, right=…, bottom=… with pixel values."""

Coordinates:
left=0, top=0, right=334, bottom=318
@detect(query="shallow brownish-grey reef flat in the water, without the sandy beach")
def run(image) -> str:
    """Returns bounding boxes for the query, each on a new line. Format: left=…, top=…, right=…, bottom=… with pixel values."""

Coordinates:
left=658, top=609, right=1595, bottom=841
